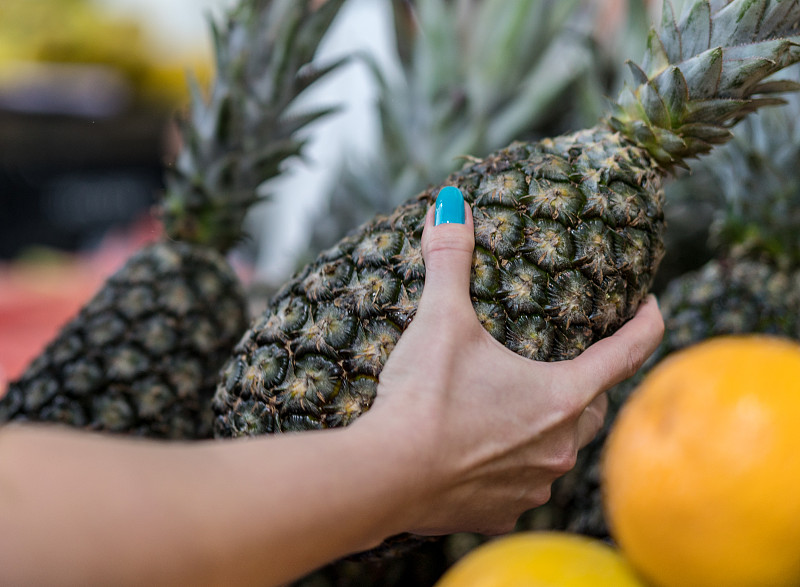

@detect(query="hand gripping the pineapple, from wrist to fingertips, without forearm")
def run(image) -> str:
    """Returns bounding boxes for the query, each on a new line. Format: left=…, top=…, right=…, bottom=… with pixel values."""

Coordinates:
left=356, top=192, right=664, bottom=535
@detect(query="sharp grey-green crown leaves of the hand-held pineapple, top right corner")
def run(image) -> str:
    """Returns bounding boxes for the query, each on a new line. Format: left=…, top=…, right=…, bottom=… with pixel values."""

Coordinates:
left=608, top=0, right=800, bottom=170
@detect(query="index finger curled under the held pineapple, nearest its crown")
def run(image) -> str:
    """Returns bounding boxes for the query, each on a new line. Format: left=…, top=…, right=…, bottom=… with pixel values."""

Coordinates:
left=572, top=295, right=664, bottom=403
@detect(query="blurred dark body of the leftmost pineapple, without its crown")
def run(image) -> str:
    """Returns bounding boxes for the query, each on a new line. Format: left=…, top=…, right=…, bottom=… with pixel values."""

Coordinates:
left=0, top=242, right=248, bottom=439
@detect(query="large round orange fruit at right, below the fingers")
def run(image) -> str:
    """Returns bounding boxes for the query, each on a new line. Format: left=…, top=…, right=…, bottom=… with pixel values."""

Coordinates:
left=602, top=335, right=800, bottom=587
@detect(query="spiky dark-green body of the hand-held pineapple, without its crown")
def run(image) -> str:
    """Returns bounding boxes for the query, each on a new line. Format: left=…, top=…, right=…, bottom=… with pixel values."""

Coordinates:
left=214, top=126, right=664, bottom=437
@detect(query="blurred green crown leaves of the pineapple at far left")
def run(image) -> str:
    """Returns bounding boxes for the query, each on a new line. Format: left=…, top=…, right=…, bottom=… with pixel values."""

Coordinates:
left=161, top=0, right=348, bottom=252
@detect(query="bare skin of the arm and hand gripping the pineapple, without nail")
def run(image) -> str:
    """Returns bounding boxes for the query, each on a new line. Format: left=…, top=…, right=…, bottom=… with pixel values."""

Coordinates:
left=0, top=203, right=663, bottom=585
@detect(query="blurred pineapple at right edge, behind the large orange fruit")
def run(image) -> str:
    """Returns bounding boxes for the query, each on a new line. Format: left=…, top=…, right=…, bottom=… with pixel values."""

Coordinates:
left=526, top=88, right=800, bottom=537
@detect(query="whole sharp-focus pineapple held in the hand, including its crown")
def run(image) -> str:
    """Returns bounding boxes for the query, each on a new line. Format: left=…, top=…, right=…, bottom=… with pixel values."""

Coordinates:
left=214, top=0, right=800, bottom=580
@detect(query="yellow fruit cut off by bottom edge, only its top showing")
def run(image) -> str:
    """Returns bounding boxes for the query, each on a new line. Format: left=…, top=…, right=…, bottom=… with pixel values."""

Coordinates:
left=436, top=532, right=644, bottom=587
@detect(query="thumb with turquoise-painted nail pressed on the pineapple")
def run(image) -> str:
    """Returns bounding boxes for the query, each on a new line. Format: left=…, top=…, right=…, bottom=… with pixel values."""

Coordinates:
left=420, top=186, right=475, bottom=308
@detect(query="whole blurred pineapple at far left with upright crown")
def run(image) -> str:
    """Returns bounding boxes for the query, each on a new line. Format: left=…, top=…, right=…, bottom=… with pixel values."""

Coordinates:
left=0, top=0, right=343, bottom=439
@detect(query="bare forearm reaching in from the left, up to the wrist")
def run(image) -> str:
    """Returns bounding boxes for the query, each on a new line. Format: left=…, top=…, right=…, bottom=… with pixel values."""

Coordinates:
left=0, top=427, right=419, bottom=585
